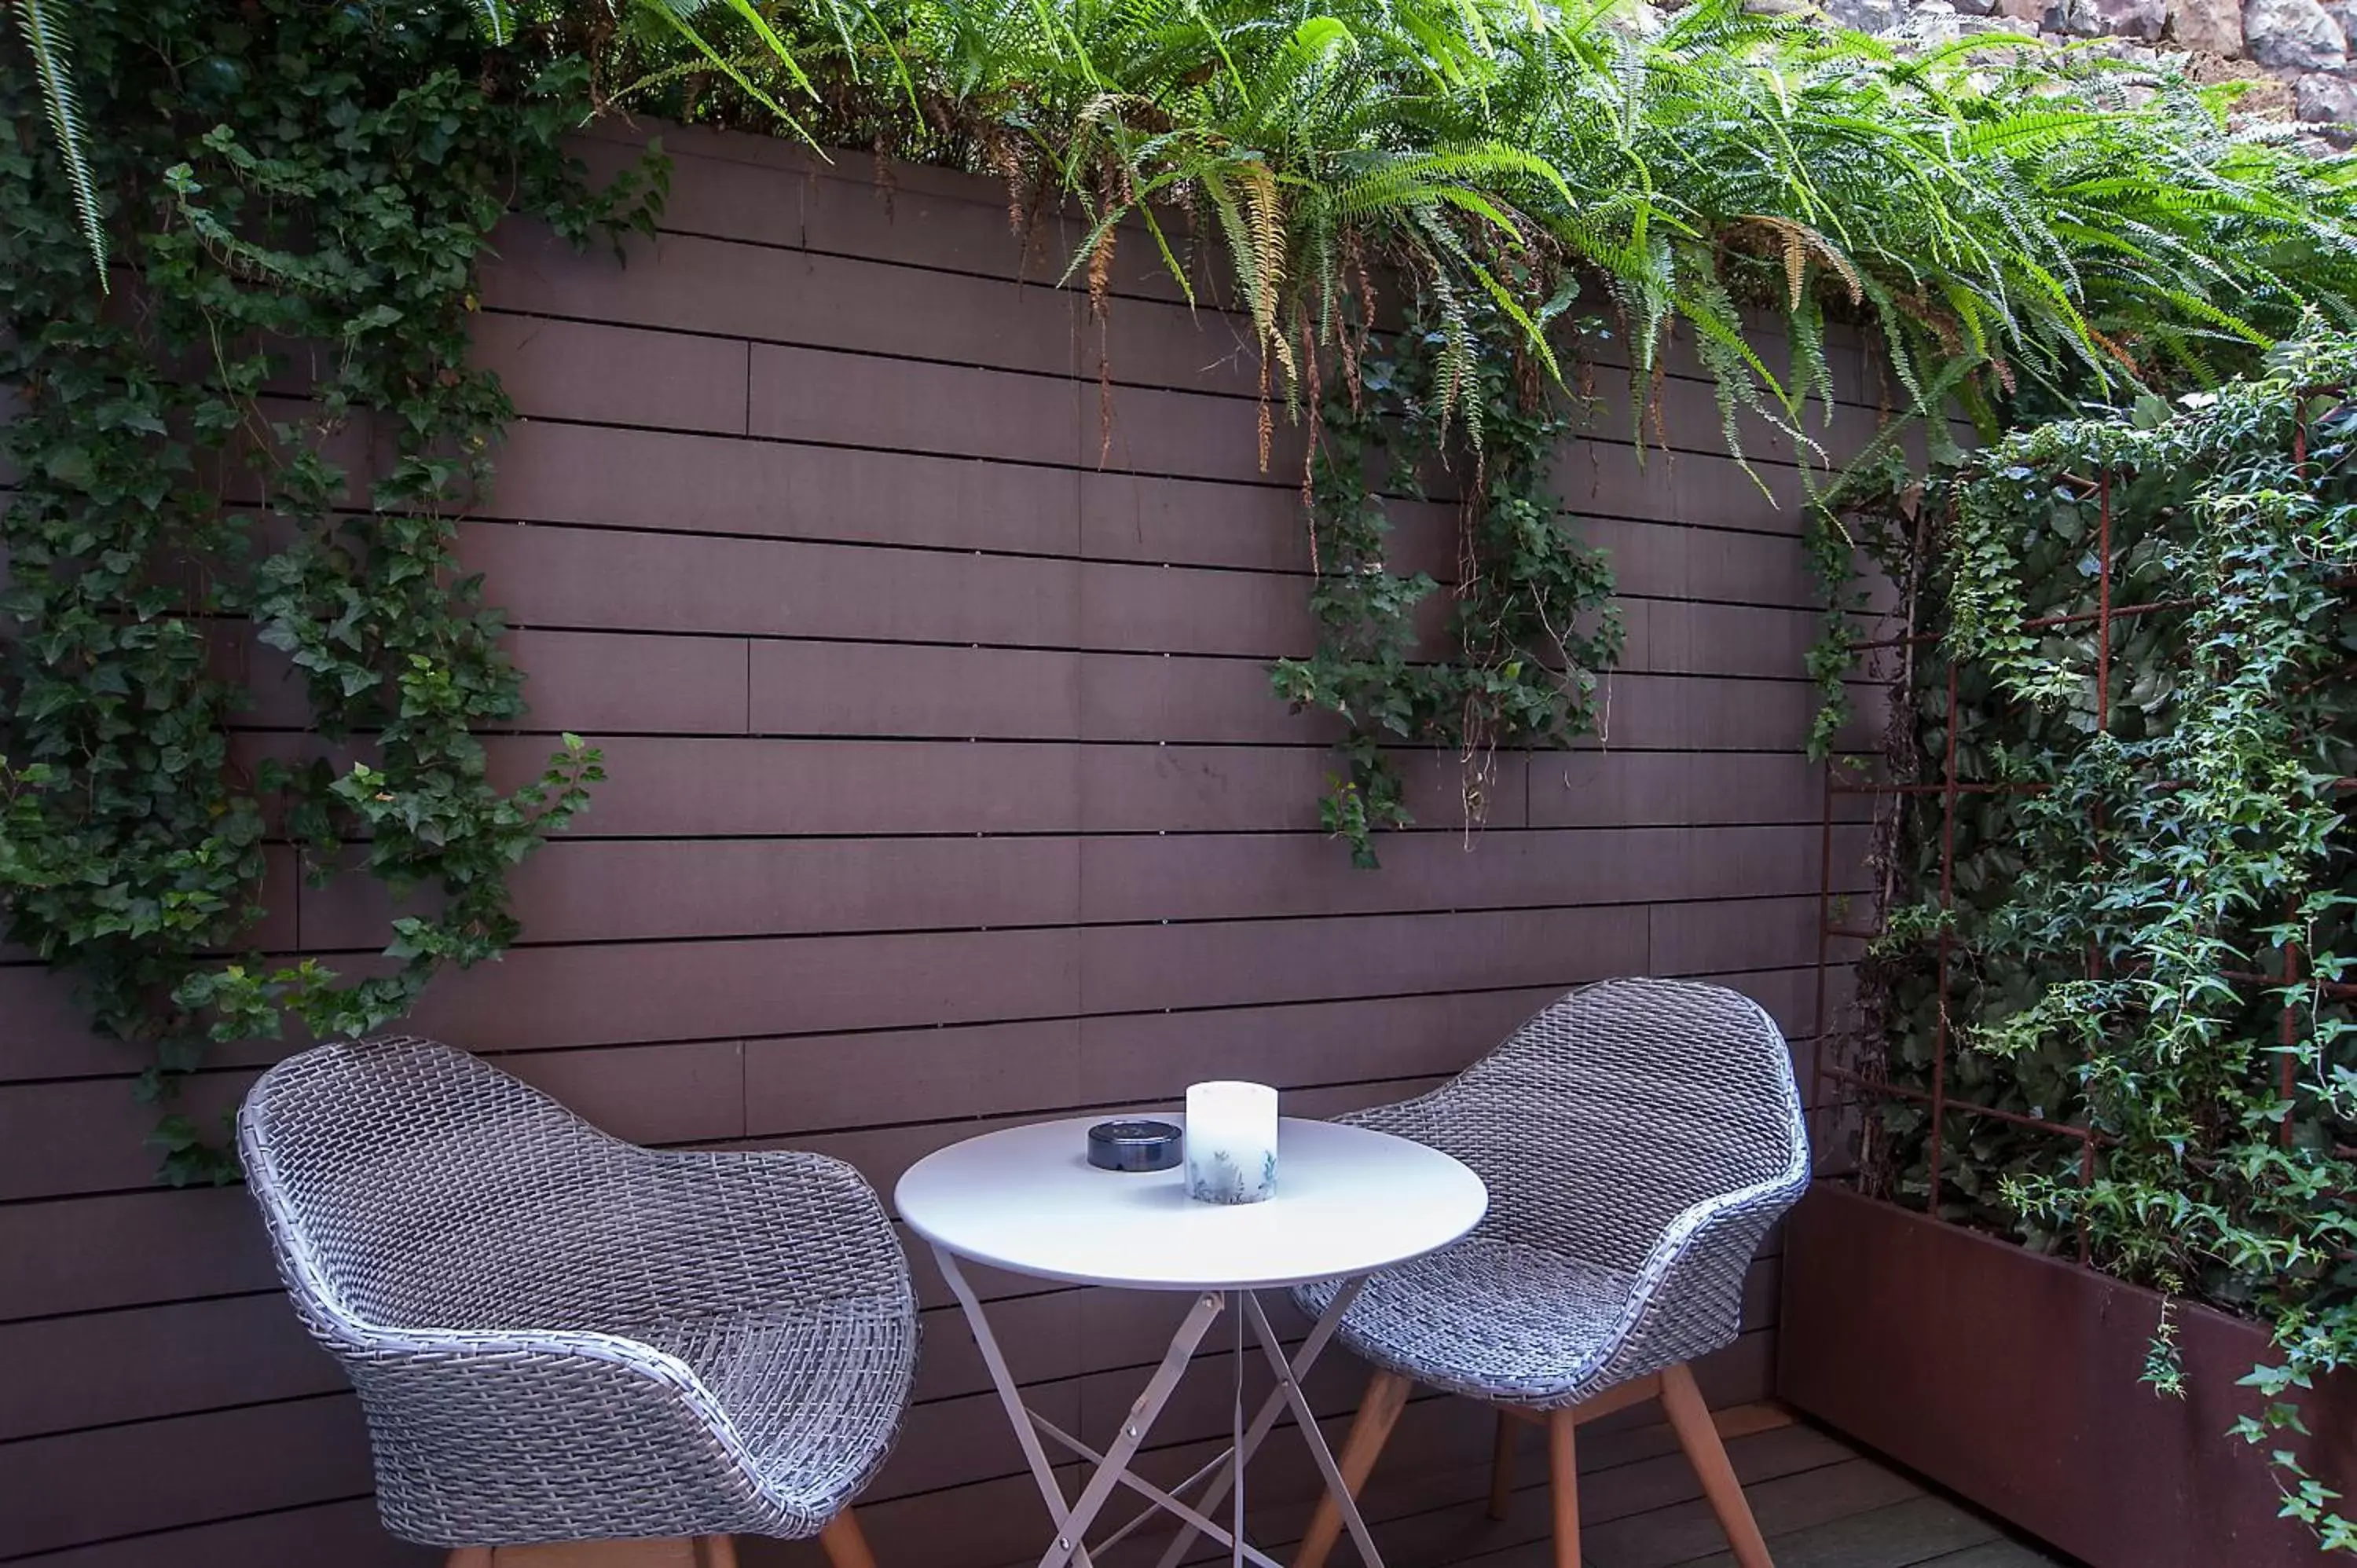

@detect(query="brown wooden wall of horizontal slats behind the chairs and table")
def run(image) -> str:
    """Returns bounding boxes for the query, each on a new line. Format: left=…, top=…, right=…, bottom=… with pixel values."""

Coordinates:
left=0, top=123, right=1874, bottom=1568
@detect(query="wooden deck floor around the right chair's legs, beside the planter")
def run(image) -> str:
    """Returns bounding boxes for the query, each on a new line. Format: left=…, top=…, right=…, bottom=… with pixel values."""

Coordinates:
left=1367, top=1405, right=2067, bottom=1568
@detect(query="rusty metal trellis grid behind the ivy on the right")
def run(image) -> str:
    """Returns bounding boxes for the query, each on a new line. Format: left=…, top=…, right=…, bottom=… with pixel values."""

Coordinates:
left=1810, top=401, right=2357, bottom=1264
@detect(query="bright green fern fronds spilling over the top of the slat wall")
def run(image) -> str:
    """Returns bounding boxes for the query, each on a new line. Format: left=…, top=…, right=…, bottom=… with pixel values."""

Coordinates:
left=601, top=0, right=2357, bottom=445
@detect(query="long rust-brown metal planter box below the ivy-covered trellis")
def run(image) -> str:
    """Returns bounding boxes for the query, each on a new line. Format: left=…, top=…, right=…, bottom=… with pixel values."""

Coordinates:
left=1777, top=1186, right=2357, bottom=1568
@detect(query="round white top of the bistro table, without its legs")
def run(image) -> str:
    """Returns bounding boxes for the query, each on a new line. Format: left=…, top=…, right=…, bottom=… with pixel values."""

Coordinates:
left=893, top=1111, right=1490, bottom=1290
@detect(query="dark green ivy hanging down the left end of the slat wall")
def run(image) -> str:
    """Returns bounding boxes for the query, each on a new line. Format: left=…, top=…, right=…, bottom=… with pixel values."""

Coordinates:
left=0, top=0, right=646, bottom=1181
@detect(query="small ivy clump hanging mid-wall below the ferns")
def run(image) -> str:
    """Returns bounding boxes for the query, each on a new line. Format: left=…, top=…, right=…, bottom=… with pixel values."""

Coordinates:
left=1270, top=295, right=1622, bottom=868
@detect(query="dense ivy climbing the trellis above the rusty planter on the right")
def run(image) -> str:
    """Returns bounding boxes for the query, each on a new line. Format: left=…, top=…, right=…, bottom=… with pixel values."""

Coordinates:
left=1853, top=330, right=2357, bottom=1552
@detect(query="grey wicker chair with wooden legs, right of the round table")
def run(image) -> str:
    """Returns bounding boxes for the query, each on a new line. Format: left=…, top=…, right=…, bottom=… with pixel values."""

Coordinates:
left=1294, top=981, right=1808, bottom=1568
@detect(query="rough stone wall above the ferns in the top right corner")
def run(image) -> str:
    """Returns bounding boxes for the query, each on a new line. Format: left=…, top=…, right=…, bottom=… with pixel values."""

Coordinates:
left=1824, top=0, right=2357, bottom=126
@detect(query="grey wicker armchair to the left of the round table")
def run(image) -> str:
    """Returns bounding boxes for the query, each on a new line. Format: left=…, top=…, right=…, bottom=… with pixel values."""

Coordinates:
left=238, top=1040, right=917, bottom=1568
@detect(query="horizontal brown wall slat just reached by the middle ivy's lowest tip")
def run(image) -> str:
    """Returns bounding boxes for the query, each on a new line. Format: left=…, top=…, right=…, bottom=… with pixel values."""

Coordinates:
left=302, top=823, right=1864, bottom=948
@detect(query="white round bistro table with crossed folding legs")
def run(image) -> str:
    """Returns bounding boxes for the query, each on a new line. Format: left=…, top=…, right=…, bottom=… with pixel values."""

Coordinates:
left=896, top=1113, right=1490, bottom=1568
